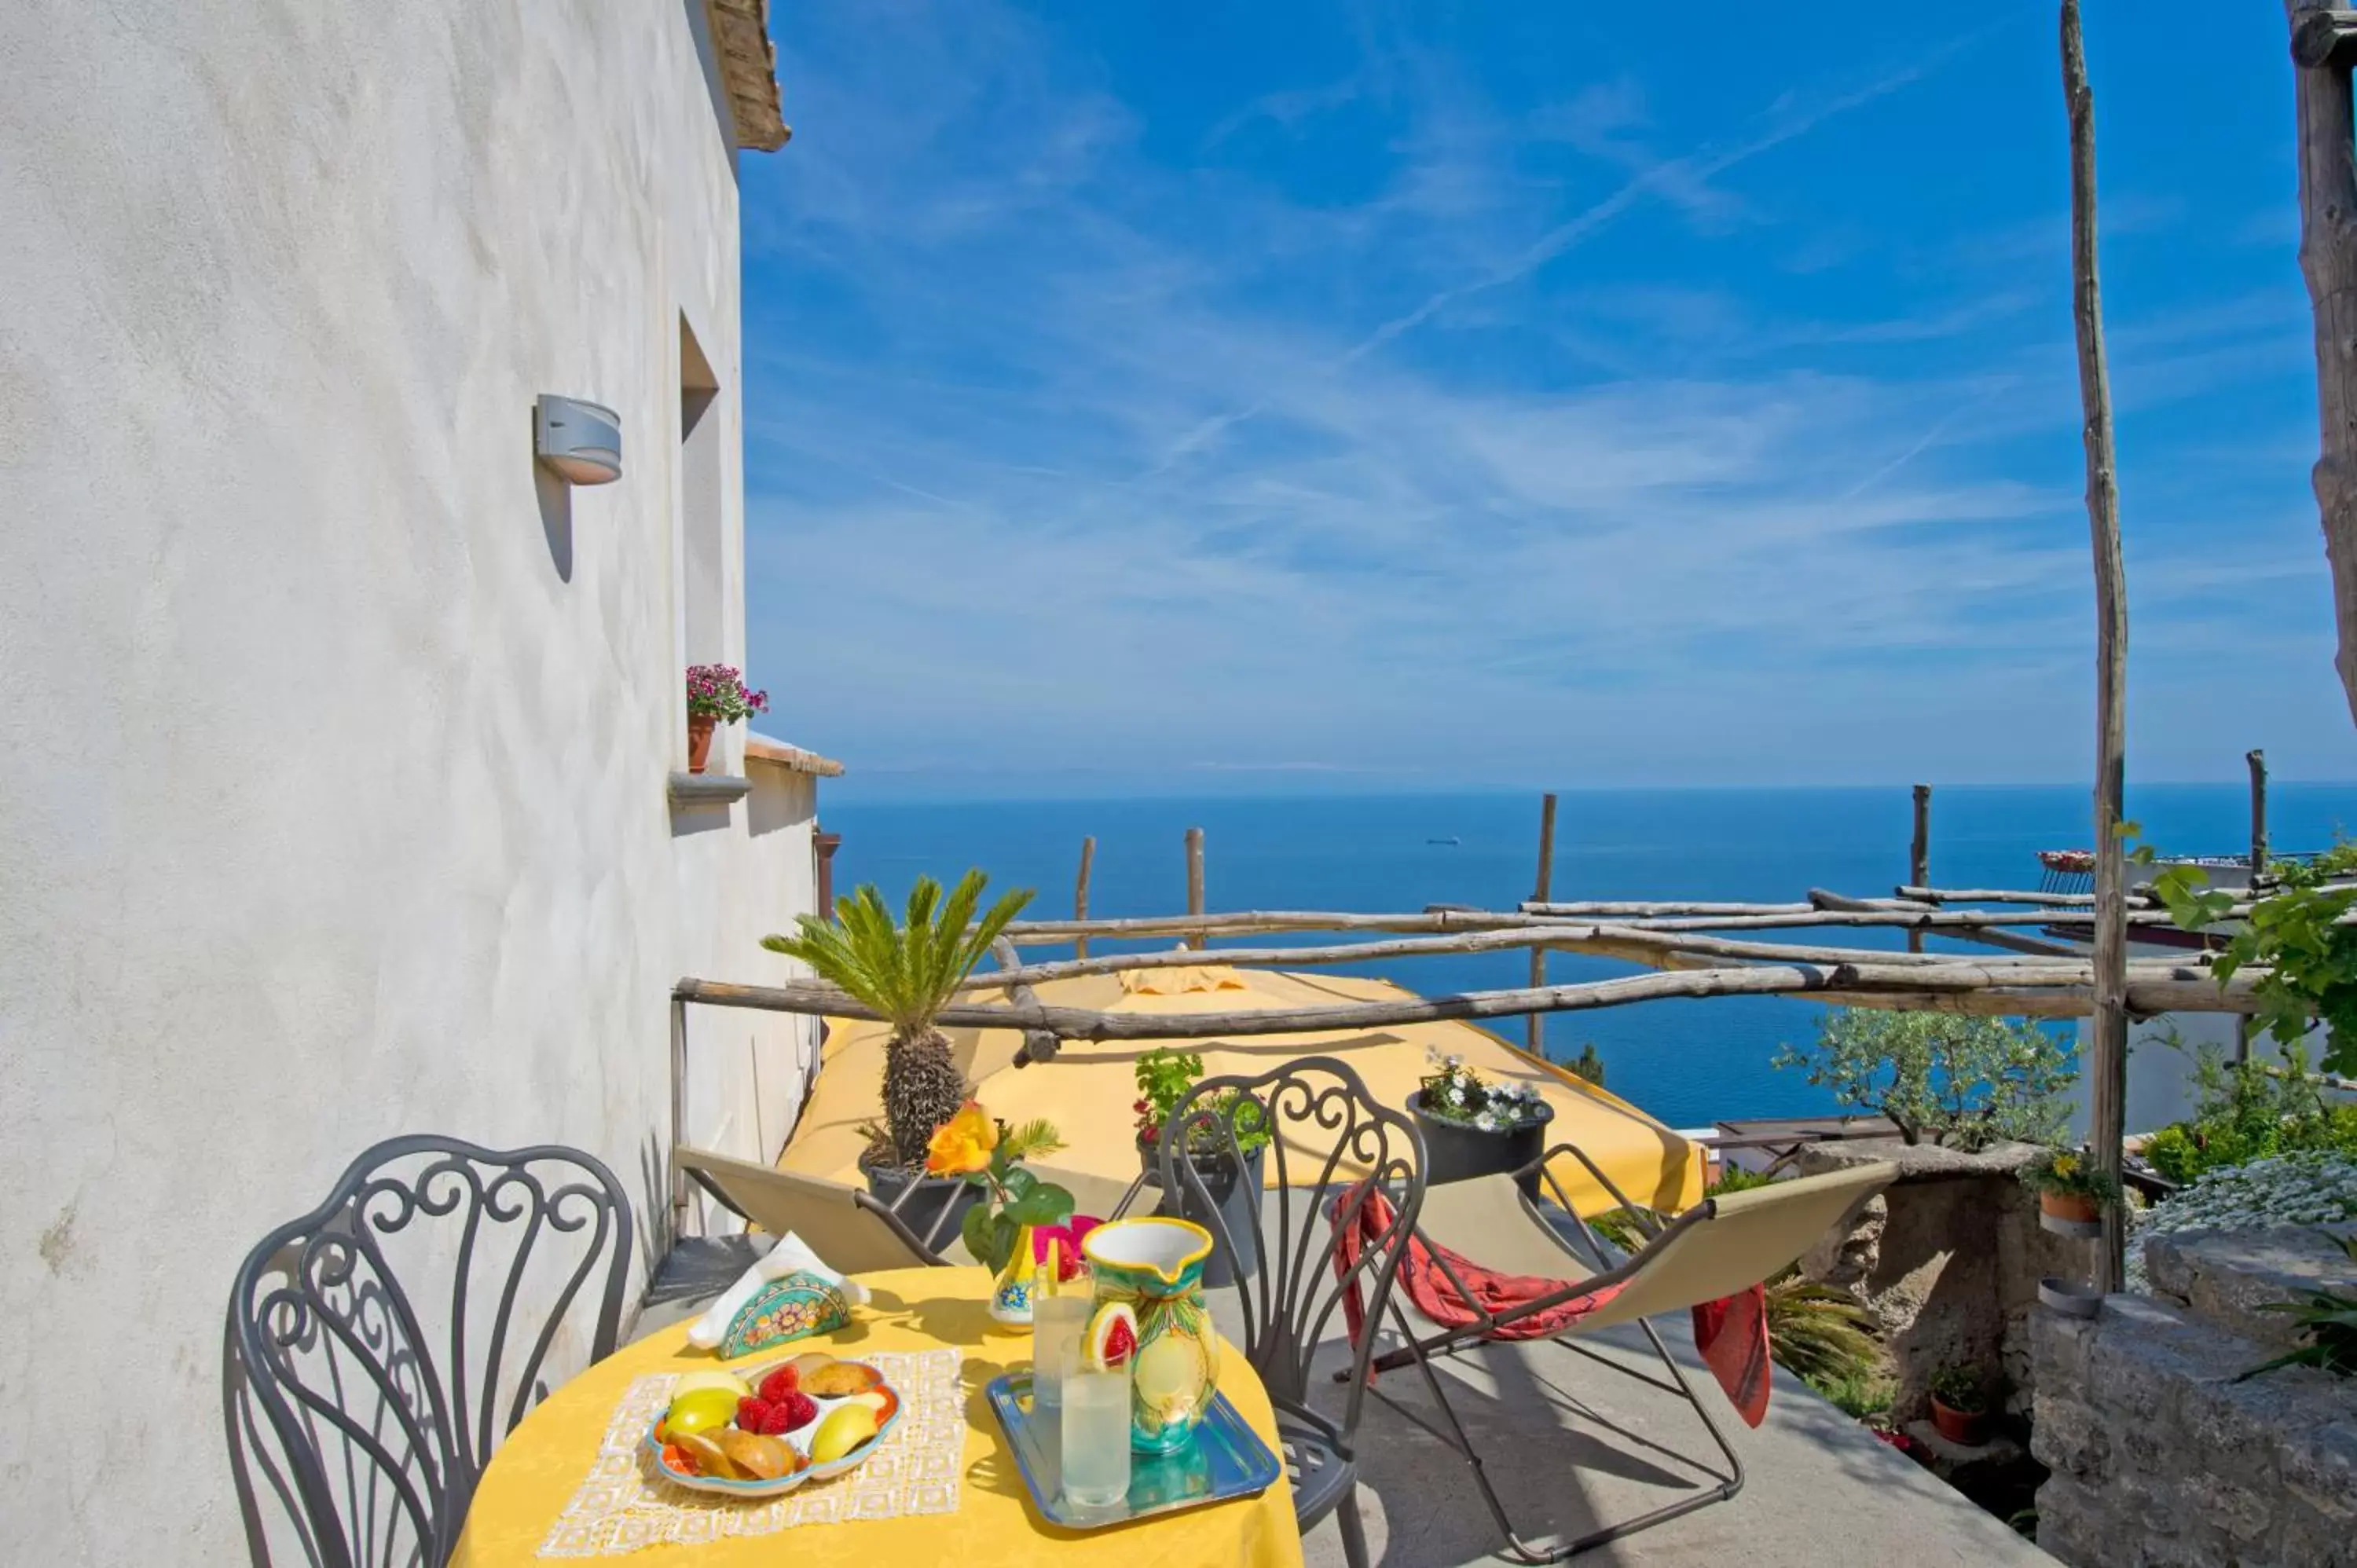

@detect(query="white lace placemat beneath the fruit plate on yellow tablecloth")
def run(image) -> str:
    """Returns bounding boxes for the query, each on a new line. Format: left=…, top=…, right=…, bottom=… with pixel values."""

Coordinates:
left=540, top=1349, right=966, bottom=1556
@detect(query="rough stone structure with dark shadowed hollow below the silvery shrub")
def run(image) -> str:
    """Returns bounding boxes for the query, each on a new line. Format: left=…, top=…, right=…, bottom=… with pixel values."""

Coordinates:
left=1798, top=1139, right=2086, bottom=1422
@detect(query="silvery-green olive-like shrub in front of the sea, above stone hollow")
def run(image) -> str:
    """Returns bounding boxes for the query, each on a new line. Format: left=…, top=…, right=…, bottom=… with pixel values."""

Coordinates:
left=1775, top=1007, right=2079, bottom=1151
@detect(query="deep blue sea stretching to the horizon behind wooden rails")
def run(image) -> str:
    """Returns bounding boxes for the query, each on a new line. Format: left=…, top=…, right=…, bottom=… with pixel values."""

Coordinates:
left=823, top=782, right=2357, bottom=1127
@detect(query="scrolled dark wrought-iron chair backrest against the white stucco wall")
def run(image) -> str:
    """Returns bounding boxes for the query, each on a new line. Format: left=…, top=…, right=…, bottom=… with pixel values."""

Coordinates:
left=222, top=1134, right=632, bottom=1568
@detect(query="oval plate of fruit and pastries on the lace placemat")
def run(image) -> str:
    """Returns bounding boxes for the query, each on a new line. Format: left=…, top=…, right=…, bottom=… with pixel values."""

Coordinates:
left=646, top=1351, right=900, bottom=1497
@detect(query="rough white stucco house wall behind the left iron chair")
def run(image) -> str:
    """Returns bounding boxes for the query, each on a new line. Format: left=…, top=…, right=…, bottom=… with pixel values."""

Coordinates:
left=0, top=0, right=811, bottom=1563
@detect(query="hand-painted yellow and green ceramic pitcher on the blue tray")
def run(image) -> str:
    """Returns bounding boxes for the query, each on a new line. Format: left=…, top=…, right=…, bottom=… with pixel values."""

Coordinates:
left=1080, top=1214, right=1219, bottom=1455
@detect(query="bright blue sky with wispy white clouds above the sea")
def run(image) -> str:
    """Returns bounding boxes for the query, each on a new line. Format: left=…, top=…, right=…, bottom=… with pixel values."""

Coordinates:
left=742, top=0, right=2357, bottom=795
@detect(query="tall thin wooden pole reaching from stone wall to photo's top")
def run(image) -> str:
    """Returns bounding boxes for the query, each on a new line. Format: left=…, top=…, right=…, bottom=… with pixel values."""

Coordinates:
left=2062, top=0, right=2128, bottom=1292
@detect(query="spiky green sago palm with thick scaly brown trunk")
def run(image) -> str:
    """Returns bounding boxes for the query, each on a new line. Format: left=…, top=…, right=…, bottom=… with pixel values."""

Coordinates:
left=761, top=868, right=1032, bottom=1170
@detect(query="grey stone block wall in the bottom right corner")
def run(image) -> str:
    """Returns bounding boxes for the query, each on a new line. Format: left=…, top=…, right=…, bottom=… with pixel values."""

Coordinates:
left=2032, top=1231, right=2357, bottom=1568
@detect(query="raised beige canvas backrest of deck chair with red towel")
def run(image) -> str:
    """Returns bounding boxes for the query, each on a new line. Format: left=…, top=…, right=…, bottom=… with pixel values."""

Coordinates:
left=1579, top=1163, right=1897, bottom=1332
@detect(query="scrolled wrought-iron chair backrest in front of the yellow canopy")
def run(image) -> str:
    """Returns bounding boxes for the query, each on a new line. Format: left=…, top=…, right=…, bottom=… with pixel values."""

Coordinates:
left=1162, top=1057, right=1424, bottom=1441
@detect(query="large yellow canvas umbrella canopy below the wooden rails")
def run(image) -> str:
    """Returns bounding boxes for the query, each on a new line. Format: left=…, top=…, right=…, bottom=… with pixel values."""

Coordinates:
left=778, top=965, right=1702, bottom=1214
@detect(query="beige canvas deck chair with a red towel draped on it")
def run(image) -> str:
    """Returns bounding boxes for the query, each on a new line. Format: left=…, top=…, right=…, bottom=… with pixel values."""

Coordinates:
left=1369, top=1144, right=1897, bottom=1563
